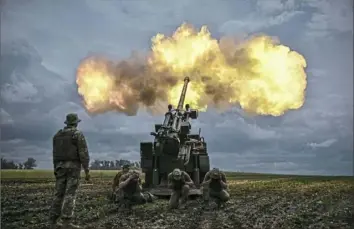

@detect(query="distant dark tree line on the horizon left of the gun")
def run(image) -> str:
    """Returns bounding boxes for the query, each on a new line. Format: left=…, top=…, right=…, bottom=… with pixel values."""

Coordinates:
left=1, top=157, right=140, bottom=170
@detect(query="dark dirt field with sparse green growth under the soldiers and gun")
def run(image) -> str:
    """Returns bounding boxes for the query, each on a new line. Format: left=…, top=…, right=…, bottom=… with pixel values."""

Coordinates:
left=1, top=171, right=354, bottom=229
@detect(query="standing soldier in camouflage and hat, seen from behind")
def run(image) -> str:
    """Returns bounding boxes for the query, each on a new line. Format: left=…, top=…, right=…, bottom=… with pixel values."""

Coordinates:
left=50, top=113, right=90, bottom=228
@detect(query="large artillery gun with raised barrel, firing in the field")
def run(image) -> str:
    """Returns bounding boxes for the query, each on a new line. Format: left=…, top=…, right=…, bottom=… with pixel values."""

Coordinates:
left=140, top=77, right=210, bottom=196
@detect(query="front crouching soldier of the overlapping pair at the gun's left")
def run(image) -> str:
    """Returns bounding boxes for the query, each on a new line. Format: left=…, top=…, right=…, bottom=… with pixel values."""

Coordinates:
left=116, top=171, right=152, bottom=208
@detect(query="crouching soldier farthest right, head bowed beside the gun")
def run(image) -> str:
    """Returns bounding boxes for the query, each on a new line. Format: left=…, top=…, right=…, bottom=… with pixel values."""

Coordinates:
left=202, top=168, right=230, bottom=206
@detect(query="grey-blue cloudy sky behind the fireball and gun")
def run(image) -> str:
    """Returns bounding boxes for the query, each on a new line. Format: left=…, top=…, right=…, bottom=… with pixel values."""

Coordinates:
left=0, top=0, right=353, bottom=175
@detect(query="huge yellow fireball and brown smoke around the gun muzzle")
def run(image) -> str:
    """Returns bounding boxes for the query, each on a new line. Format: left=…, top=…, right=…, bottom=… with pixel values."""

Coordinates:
left=76, top=24, right=306, bottom=116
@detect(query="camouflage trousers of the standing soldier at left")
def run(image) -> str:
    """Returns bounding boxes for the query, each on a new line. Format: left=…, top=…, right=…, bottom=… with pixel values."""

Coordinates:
left=50, top=167, right=80, bottom=221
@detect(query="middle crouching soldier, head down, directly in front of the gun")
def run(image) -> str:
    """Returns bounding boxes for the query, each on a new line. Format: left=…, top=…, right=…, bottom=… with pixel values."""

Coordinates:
left=167, top=169, right=194, bottom=209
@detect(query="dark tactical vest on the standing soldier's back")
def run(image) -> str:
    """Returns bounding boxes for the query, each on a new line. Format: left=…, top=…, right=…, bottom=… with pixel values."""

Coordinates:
left=53, top=130, right=80, bottom=161
